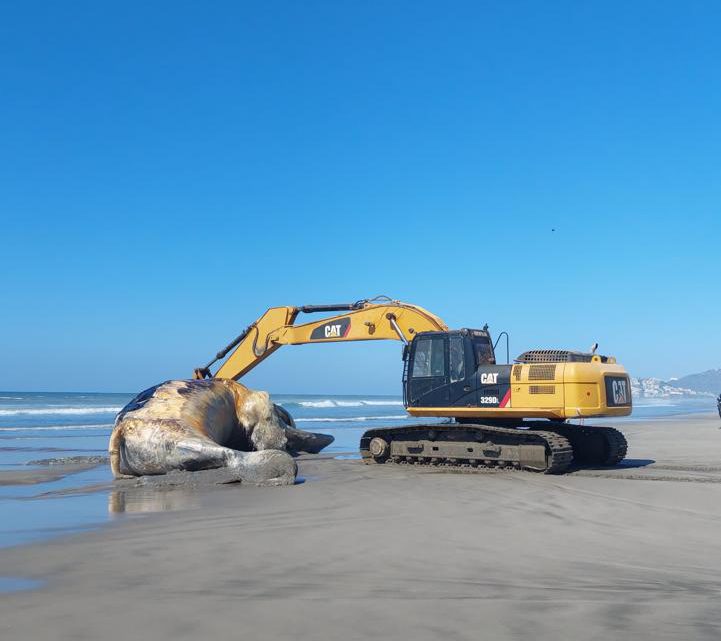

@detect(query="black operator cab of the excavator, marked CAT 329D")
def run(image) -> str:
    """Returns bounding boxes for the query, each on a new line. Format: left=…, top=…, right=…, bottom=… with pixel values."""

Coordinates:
left=403, top=329, right=511, bottom=407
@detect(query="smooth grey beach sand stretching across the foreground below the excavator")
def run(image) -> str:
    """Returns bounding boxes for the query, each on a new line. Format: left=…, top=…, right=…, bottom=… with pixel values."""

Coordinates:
left=0, top=414, right=721, bottom=641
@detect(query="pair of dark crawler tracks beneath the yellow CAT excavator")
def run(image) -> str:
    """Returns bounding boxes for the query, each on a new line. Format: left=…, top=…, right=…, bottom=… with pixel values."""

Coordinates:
left=360, top=421, right=628, bottom=474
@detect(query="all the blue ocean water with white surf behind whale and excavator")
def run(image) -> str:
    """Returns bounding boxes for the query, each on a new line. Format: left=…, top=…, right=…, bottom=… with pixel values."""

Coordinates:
left=0, top=392, right=715, bottom=547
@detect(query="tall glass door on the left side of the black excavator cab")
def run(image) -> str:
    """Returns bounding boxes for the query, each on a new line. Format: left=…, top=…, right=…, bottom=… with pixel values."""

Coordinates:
left=408, top=334, right=450, bottom=407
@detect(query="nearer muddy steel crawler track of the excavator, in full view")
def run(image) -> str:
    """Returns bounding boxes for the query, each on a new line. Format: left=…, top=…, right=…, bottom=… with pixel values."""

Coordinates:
left=360, top=423, right=573, bottom=474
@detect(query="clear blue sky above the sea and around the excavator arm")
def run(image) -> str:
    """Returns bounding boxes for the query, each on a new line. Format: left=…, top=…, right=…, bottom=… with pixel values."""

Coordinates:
left=0, top=1, right=721, bottom=394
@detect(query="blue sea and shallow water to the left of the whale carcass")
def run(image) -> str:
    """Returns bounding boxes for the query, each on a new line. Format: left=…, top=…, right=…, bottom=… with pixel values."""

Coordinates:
left=0, top=392, right=126, bottom=547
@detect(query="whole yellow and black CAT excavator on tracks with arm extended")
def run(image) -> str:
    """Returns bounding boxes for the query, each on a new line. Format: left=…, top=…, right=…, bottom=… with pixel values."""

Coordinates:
left=194, top=296, right=632, bottom=474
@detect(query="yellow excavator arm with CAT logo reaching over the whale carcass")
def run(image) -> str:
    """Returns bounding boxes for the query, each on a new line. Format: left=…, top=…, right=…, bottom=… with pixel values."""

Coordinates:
left=194, top=297, right=448, bottom=380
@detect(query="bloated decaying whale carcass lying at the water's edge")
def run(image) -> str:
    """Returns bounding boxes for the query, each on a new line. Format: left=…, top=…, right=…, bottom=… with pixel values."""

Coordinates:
left=108, top=379, right=333, bottom=485
